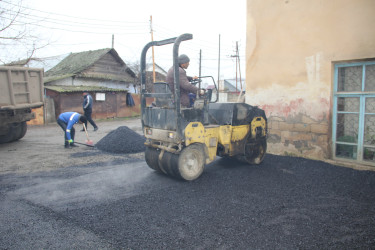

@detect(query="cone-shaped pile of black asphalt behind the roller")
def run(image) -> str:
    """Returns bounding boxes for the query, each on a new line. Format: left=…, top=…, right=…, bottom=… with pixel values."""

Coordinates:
left=95, top=126, right=145, bottom=154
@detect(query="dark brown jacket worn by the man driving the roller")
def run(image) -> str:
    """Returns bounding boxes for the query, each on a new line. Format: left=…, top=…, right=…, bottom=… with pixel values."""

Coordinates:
left=167, top=67, right=198, bottom=107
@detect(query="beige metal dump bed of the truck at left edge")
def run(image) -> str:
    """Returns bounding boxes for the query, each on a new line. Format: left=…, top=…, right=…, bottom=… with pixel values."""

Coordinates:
left=0, top=66, right=43, bottom=110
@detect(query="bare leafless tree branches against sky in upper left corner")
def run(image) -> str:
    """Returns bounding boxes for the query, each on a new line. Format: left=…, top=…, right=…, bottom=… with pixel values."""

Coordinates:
left=0, top=0, right=48, bottom=65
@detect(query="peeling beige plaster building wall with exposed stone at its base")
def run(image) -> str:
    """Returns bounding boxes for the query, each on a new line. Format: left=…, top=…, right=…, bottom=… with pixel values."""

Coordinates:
left=246, top=0, right=375, bottom=159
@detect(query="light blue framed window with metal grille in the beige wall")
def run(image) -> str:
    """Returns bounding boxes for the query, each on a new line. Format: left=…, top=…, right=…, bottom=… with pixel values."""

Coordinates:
left=332, top=61, right=375, bottom=165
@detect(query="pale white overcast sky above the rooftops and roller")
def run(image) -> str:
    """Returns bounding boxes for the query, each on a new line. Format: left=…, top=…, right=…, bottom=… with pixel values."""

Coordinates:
left=0, top=0, right=246, bottom=79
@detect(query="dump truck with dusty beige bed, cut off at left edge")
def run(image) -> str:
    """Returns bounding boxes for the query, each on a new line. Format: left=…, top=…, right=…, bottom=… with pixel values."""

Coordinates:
left=0, top=66, right=44, bottom=143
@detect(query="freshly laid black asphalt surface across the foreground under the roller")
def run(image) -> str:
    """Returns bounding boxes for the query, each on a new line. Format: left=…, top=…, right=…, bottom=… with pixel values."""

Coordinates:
left=0, top=150, right=375, bottom=249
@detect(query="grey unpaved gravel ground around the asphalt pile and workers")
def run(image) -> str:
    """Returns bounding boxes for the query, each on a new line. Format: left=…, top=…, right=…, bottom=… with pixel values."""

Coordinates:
left=0, top=118, right=144, bottom=174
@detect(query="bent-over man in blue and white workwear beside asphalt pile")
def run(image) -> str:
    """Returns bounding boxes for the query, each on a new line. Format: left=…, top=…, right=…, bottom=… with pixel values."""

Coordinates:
left=57, top=112, right=87, bottom=148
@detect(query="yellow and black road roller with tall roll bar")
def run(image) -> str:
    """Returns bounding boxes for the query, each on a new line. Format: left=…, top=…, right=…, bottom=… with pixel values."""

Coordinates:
left=140, top=34, right=267, bottom=181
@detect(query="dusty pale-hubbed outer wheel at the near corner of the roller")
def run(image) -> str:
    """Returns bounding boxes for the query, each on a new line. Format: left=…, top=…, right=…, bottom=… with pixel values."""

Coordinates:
left=177, top=144, right=205, bottom=181
